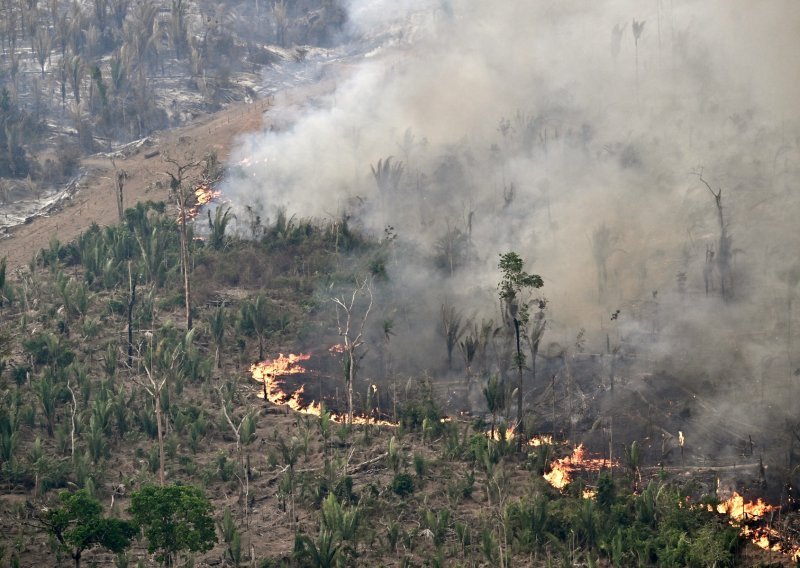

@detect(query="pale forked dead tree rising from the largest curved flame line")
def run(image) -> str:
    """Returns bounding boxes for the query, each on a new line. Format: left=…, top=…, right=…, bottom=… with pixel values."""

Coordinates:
left=331, top=278, right=372, bottom=424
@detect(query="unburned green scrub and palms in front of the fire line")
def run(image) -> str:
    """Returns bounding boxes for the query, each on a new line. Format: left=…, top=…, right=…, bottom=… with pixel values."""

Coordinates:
left=0, top=171, right=788, bottom=567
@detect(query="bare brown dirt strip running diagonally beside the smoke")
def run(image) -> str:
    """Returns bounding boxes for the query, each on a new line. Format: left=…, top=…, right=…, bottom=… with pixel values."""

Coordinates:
left=0, top=77, right=335, bottom=270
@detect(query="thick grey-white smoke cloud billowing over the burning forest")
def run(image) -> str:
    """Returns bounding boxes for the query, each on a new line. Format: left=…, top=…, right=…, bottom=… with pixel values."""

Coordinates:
left=223, top=0, right=800, bottom=460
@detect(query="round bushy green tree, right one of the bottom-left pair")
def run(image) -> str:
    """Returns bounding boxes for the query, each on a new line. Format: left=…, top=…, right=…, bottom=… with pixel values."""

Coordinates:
left=130, top=485, right=217, bottom=564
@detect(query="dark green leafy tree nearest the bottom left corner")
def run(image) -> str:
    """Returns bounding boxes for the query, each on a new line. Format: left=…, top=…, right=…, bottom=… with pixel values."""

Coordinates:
left=40, top=489, right=136, bottom=565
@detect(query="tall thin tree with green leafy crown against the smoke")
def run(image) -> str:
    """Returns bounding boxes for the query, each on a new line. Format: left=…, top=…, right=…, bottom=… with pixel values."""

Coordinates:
left=497, top=252, right=544, bottom=432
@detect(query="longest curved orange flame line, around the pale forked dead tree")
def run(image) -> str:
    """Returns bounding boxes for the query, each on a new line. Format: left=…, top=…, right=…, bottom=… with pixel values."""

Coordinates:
left=245, top=353, right=397, bottom=426
